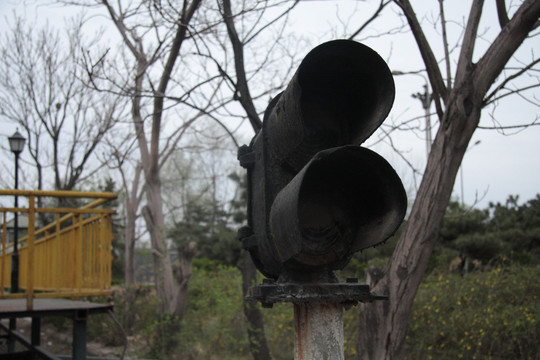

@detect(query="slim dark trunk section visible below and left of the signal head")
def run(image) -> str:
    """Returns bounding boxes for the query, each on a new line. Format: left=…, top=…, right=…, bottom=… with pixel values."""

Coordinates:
left=241, top=251, right=271, bottom=360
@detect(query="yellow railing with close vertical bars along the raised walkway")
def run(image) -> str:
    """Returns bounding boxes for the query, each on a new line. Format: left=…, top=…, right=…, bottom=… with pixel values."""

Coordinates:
left=0, top=190, right=116, bottom=309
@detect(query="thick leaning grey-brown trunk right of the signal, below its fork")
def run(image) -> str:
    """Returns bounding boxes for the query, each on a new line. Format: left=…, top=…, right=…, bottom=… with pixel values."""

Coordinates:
left=357, top=94, right=480, bottom=360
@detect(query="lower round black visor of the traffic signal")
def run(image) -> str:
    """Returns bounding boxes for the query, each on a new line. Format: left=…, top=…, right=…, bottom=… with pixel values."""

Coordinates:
left=270, top=145, right=406, bottom=269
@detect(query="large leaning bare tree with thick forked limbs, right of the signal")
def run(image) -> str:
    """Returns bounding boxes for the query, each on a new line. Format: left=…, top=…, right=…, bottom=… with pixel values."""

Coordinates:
left=357, top=0, right=540, bottom=359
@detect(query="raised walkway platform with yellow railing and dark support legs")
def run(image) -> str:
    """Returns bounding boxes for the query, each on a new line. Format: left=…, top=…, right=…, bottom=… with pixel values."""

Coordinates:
left=0, top=190, right=116, bottom=360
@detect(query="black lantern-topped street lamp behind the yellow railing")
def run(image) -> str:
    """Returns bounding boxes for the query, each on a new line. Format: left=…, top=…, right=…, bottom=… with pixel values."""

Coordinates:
left=8, top=129, right=26, bottom=294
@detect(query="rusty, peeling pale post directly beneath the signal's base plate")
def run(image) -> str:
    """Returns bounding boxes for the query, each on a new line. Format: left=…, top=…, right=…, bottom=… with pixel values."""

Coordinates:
left=294, top=303, right=345, bottom=360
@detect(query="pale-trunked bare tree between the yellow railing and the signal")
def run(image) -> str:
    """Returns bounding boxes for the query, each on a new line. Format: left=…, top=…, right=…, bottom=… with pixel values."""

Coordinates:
left=69, top=0, right=219, bottom=329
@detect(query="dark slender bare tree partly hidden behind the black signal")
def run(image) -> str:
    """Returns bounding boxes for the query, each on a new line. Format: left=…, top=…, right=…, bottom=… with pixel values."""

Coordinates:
left=218, top=0, right=298, bottom=360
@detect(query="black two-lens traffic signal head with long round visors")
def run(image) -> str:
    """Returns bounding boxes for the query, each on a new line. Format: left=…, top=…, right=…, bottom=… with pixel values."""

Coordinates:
left=238, top=40, right=407, bottom=283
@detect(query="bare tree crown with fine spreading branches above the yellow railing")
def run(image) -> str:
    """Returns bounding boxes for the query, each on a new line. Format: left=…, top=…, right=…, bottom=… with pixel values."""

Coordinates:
left=0, top=18, right=123, bottom=206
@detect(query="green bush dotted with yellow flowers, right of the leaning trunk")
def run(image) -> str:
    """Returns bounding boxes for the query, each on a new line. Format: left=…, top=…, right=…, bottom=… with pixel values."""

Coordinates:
left=406, top=266, right=540, bottom=359
